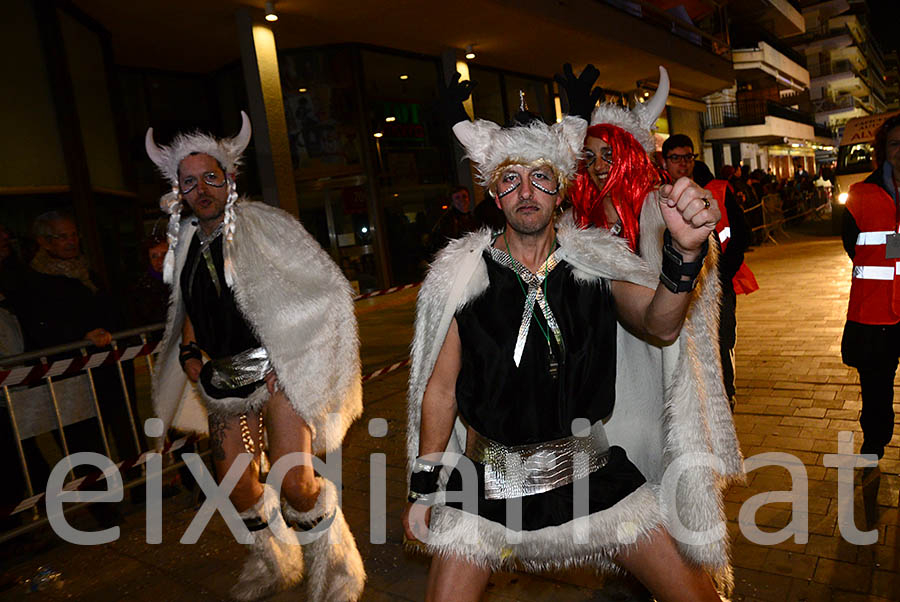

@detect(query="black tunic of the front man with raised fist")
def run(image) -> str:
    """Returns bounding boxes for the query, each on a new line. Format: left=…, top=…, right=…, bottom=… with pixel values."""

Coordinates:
left=447, top=252, right=645, bottom=531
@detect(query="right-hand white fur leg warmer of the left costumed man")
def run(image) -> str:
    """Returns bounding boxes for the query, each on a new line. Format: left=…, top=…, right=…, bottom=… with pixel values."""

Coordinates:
left=284, top=477, right=366, bottom=602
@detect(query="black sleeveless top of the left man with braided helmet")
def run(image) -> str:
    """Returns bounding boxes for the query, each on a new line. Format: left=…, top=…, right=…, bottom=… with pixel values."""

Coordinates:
left=179, top=234, right=260, bottom=359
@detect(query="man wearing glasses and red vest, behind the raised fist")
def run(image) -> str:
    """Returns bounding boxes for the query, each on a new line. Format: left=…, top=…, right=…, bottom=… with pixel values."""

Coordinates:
left=662, top=134, right=759, bottom=409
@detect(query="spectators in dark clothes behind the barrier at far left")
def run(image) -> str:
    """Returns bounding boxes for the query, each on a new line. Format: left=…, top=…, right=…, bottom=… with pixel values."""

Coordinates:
left=0, top=211, right=168, bottom=524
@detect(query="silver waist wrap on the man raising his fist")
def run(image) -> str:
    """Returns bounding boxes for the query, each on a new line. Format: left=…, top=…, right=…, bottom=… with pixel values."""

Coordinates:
left=466, top=420, right=609, bottom=500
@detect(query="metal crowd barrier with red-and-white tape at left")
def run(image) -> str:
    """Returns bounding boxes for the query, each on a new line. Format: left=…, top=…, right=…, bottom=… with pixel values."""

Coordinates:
left=0, top=283, right=418, bottom=543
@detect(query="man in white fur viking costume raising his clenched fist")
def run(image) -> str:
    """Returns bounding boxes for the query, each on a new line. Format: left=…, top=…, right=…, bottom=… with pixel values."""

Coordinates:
left=404, top=76, right=742, bottom=601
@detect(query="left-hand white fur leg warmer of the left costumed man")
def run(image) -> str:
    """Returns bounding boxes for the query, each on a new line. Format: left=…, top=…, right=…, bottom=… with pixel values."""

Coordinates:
left=231, top=485, right=303, bottom=600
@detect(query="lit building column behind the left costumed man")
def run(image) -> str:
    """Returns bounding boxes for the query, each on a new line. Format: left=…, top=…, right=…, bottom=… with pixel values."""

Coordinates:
left=236, top=8, right=300, bottom=216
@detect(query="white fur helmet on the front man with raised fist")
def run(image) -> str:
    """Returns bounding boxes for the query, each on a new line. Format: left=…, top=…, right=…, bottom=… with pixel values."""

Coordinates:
left=453, top=116, right=587, bottom=191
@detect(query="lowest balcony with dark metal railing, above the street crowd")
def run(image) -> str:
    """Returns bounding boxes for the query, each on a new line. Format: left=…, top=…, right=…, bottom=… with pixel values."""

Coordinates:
left=701, top=100, right=819, bottom=144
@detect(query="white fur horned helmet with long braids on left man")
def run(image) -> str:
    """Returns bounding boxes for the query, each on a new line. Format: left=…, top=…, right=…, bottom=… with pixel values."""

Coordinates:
left=144, top=111, right=251, bottom=286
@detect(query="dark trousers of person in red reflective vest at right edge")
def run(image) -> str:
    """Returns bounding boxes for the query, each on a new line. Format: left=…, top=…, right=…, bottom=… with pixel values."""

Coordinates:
left=858, top=359, right=897, bottom=458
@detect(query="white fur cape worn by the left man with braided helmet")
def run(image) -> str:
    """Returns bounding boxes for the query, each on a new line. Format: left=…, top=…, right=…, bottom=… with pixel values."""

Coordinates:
left=153, top=201, right=362, bottom=454
